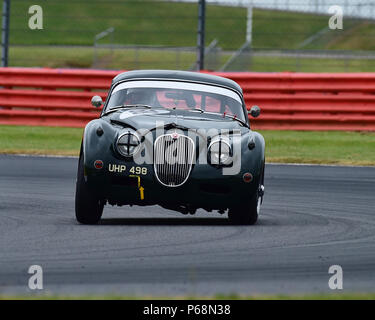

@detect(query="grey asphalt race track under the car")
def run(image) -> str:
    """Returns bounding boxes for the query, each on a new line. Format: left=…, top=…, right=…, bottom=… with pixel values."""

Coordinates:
left=0, top=155, right=375, bottom=295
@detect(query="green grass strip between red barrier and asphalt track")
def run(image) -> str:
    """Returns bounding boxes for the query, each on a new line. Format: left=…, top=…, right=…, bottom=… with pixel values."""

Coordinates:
left=0, top=125, right=375, bottom=165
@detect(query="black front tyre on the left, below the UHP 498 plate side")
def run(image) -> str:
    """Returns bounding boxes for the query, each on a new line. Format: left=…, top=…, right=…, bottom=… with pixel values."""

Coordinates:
left=75, top=156, right=104, bottom=224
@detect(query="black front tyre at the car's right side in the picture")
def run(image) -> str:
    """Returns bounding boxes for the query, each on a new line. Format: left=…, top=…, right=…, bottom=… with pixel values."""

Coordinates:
left=228, top=192, right=260, bottom=225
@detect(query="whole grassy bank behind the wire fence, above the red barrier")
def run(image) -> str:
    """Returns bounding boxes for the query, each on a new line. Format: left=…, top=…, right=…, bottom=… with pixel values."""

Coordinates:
left=4, top=0, right=375, bottom=72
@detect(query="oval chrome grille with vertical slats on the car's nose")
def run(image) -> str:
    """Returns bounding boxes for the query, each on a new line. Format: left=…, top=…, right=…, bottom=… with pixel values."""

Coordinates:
left=154, top=133, right=195, bottom=187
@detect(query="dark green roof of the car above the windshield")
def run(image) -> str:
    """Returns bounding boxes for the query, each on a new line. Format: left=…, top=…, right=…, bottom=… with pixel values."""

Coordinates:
left=112, top=70, right=242, bottom=95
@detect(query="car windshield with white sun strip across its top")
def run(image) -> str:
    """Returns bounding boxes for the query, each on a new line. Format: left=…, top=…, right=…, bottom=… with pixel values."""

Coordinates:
left=106, top=80, right=246, bottom=121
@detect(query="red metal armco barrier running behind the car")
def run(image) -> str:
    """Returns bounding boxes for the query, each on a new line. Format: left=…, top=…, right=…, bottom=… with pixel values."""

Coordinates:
left=0, top=68, right=375, bottom=131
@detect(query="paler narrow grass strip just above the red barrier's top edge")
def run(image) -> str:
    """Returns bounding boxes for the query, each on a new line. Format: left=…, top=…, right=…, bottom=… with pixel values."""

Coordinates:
left=10, top=47, right=375, bottom=72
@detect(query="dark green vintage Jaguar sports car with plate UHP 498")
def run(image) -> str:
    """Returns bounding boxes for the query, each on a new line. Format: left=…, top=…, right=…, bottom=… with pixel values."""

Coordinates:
left=75, top=70, right=265, bottom=224
